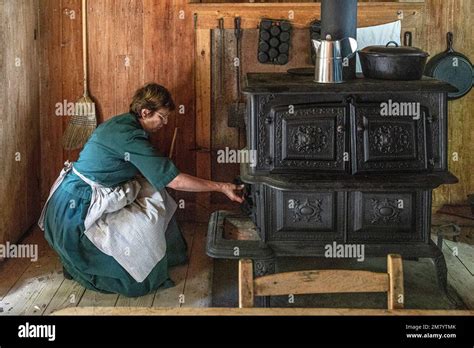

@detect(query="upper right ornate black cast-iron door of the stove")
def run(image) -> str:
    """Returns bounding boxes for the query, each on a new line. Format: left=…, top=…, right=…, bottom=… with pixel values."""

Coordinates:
left=352, top=104, right=429, bottom=173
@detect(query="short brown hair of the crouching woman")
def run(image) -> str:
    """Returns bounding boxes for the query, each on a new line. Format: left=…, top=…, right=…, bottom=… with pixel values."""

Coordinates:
left=130, top=83, right=175, bottom=117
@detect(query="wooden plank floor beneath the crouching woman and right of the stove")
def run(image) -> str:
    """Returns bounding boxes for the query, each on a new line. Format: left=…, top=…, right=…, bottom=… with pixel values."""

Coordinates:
left=0, top=223, right=474, bottom=315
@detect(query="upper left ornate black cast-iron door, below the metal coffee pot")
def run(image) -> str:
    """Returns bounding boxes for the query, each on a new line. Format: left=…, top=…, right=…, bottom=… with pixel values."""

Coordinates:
left=270, top=104, right=349, bottom=172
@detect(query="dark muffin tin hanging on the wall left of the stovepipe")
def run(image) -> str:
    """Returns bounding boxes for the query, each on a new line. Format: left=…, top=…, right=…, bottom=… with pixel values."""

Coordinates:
left=258, top=19, right=292, bottom=65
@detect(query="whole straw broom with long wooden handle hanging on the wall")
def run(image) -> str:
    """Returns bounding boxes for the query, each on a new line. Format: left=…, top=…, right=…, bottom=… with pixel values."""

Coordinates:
left=63, top=0, right=97, bottom=151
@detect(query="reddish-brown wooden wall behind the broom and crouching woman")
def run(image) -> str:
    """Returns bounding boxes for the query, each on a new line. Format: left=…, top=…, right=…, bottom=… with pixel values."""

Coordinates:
left=40, top=0, right=195, bottom=205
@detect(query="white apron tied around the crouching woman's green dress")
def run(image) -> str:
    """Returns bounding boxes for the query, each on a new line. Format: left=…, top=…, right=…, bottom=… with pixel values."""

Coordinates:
left=38, top=162, right=177, bottom=283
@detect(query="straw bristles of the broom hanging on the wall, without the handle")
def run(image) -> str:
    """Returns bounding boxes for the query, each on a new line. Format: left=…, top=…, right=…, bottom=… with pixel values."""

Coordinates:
left=63, top=96, right=97, bottom=151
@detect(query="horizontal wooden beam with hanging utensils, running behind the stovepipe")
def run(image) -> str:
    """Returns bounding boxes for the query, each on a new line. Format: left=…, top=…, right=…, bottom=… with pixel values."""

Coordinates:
left=189, top=2, right=425, bottom=29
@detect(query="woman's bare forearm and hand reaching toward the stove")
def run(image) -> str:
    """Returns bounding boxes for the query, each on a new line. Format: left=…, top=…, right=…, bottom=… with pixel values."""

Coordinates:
left=168, top=173, right=244, bottom=203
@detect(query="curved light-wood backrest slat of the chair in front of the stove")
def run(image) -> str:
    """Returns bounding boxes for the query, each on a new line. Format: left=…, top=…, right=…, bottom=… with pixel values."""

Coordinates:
left=254, top=270, right=388, bottom=296
